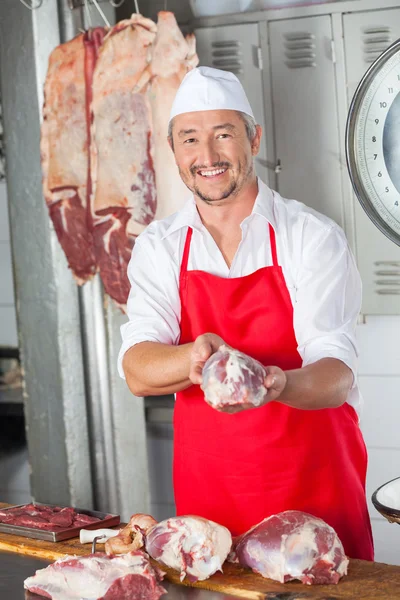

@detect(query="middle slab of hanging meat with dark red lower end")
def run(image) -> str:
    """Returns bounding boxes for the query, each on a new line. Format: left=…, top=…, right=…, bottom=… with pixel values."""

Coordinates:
left=91, top=14, right=157, bottom=306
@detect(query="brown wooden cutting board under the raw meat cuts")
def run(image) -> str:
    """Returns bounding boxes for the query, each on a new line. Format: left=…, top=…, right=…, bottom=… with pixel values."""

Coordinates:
left=0, top=503, right=400, bottom=600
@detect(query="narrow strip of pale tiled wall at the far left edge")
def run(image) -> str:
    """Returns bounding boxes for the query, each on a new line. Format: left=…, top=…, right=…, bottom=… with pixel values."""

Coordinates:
left=0, top=182, right=18, bottom=347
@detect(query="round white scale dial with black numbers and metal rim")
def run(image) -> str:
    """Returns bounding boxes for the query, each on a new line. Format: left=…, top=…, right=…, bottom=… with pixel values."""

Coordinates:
left=346, top=40, right=400, bottom=246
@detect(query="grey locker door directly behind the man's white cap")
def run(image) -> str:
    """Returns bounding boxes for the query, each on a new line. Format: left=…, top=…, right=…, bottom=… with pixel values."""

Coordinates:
left=195, top=23, right=268, bottom=183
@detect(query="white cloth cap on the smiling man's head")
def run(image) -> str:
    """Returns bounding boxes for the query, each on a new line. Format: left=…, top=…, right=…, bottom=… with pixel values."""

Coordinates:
left=169, top=67, right=254, bottom=121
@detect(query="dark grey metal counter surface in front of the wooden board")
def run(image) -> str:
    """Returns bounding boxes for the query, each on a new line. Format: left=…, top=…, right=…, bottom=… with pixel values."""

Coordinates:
left=0, top=552, right=241, bottom=600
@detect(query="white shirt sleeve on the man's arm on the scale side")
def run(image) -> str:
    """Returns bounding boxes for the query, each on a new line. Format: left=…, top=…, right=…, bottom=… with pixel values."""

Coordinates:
left=294, top=218, right=362, bottom=388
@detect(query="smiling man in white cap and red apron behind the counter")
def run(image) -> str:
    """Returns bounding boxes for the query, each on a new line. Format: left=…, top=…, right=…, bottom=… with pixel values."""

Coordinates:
left=119, top=67, right=373, bottom=560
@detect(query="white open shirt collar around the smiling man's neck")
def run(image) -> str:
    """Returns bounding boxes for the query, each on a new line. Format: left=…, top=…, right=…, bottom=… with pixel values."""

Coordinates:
left=162, top=178, right=276, bottom=239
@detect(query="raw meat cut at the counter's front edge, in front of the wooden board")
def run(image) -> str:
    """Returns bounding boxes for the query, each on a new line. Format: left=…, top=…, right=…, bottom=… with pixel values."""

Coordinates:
left=24, top=552, right=166, bottom=600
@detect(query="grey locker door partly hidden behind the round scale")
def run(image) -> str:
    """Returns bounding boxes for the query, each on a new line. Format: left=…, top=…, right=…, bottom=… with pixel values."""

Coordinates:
left=343, top=9, right=400, bottom=315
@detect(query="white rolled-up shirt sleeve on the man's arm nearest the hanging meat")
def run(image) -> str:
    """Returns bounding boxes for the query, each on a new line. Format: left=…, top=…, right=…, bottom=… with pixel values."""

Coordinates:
left=118, top=238, right=181, bottom=379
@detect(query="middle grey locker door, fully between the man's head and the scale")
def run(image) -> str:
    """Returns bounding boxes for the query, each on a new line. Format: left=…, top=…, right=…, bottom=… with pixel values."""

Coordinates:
left=268, top=15, right=343, bottom=225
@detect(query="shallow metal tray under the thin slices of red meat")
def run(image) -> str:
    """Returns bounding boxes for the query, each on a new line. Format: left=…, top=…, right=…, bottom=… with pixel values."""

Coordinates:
left=0, top=502, right=120, bottom=542
